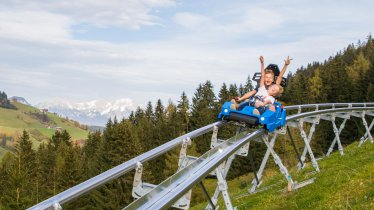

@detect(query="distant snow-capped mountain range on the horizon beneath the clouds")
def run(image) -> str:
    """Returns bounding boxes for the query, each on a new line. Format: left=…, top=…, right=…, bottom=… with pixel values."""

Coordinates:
left=36, top=98, right=136, bottom=126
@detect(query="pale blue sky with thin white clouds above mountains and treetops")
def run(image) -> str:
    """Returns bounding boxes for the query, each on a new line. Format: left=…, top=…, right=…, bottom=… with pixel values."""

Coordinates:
left=0, top=0, right=374, bottom=107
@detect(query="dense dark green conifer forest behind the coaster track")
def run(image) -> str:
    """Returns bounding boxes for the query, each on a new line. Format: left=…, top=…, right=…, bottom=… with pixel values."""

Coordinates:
left=0, top=35, right=374, bottom=209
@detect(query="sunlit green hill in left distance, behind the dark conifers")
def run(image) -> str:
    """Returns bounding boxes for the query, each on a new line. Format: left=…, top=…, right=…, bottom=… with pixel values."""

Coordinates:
left=0, top=102, right=88, bottom=159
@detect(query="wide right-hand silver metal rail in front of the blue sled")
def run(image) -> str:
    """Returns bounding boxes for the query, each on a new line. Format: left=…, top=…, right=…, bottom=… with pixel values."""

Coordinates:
left=125, top=129, right=265, bottom=209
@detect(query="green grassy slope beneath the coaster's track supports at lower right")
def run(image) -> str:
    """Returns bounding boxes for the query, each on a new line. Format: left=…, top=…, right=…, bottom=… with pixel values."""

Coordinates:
left=192, top=142, right=374, bottom=210
